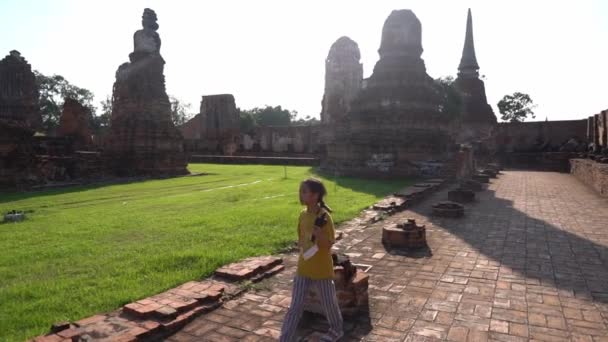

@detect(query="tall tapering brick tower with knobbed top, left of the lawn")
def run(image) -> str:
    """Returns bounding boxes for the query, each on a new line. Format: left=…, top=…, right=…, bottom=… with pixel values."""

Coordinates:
left=106, top=8, right=188, bottom=176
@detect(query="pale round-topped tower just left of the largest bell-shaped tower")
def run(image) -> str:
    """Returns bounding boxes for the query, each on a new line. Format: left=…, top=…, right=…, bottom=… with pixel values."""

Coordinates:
left=321, top=37, right=363, bottom=124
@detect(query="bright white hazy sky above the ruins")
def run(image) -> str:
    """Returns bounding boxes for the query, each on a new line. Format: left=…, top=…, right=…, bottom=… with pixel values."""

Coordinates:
left=0, top=0, right=608, bottom=120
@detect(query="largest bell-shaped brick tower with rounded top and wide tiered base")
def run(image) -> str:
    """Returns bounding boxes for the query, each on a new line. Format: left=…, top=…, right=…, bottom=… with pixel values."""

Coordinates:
left=321, top=10, right=453, bottom=177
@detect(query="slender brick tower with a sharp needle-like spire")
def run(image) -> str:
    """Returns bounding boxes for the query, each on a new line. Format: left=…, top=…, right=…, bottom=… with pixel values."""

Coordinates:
left=454, top=9, right=496, bottom=141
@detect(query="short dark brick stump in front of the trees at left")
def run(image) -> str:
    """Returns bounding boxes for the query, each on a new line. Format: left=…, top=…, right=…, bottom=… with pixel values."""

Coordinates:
left=57, top=98, right=93, bottom=150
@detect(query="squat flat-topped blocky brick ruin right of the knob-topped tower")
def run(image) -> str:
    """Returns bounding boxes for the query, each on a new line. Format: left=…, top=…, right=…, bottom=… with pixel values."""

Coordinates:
left=180, top=94, right=241, bottom=155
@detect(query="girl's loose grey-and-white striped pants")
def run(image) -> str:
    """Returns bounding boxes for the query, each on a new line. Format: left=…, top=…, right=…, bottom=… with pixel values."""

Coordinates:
left=279, top=276, right=342, bottom=342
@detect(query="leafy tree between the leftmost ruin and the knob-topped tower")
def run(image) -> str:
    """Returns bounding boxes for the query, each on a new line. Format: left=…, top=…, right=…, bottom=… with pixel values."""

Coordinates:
left=34, top=71, right=96, bottom=133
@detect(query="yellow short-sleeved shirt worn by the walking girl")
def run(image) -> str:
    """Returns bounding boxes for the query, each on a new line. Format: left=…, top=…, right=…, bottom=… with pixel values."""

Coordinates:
left=298, top=209, right=335, bottom=280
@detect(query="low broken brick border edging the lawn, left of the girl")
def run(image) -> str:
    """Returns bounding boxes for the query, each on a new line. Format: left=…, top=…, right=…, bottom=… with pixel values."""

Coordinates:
left=34, top=256, right=284, bottom=342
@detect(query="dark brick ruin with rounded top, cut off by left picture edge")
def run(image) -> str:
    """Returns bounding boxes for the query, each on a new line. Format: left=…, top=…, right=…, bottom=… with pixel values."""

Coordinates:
left=0, top=50, right=42, bottom=187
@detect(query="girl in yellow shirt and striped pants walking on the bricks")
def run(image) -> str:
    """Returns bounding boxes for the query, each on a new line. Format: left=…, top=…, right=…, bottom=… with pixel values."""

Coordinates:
left=280, top=178, right=343, bottom=342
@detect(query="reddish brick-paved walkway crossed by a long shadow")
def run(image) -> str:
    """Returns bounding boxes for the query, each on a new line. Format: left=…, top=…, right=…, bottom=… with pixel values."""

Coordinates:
left=170, top=171, right=608, bottom=342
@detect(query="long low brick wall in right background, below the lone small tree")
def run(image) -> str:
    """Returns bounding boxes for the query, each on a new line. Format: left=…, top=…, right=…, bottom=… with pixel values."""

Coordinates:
left=496, top=120, right=587, bottom=152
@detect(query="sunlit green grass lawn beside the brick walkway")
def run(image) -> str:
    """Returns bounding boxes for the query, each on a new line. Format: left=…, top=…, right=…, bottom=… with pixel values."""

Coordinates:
left=0, top=164, right=408, bottom=341
